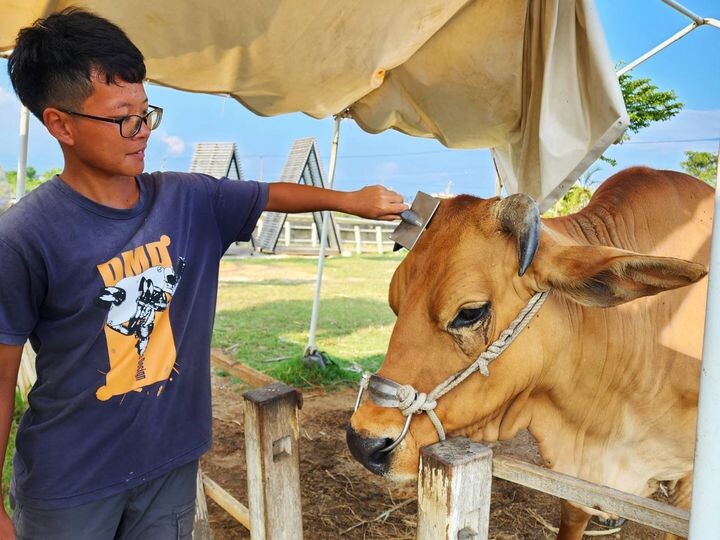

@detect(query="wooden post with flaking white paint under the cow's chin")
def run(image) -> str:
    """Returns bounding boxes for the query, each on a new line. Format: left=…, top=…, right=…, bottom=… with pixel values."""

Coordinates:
left=416, top=437, right=492, bottom=540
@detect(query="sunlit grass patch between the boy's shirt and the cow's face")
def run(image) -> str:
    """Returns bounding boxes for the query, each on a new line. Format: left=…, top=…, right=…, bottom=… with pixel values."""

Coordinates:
left=213, top=253, right=403, bottom=387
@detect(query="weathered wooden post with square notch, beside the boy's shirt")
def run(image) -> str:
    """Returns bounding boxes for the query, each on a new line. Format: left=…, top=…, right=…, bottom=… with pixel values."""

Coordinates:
left=243, top=383, right=302, bottom=540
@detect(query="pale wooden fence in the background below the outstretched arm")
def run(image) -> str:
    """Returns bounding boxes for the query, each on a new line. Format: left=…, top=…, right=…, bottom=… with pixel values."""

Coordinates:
left=258, top=214, right=397, bottom=253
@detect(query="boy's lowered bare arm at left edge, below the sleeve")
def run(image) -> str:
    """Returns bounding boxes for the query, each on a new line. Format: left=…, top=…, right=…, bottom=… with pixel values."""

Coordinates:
left=0, top=344, right=23, bottom=539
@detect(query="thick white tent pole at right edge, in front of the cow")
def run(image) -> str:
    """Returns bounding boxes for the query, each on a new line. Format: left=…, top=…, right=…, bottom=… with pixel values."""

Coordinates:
left=689, top=148, right=720, bottom=540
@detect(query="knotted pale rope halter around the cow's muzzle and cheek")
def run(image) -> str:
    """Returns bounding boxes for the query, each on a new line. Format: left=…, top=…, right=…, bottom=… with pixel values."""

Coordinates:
left=355, top=291, right=548, bottom=452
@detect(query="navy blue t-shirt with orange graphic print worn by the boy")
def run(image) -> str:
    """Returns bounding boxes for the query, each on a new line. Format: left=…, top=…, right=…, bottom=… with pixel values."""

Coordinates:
left=0, top=173, right=267, bottom=508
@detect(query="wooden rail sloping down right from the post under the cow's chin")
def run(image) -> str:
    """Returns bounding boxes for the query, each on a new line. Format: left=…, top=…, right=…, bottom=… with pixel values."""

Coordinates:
left=493, top=456, right=690, bottom=537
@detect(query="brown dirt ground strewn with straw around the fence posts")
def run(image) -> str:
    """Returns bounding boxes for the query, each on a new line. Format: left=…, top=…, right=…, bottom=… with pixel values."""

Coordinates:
left=202, top=377, right=662, bottom=540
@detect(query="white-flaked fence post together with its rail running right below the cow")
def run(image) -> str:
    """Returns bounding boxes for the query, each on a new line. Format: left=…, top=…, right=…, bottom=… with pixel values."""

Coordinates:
left=418, top=437, right=690, bottom=540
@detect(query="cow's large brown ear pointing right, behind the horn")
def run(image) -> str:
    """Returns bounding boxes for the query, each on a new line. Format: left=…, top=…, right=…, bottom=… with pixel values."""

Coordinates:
left=537, top=246, right=707, bottom=307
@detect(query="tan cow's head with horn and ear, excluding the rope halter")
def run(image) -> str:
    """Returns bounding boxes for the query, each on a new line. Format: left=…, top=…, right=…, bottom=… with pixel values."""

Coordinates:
left=347, top=195, right=706, bottom=479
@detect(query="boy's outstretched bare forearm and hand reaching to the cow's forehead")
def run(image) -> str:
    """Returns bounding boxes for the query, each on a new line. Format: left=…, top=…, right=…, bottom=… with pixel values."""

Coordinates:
left=265, top=182, right=408, bottom=220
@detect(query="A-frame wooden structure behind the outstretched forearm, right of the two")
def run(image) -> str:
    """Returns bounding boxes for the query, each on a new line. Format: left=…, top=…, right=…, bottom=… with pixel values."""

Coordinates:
left=257, top=138, right=342, bottom=253
